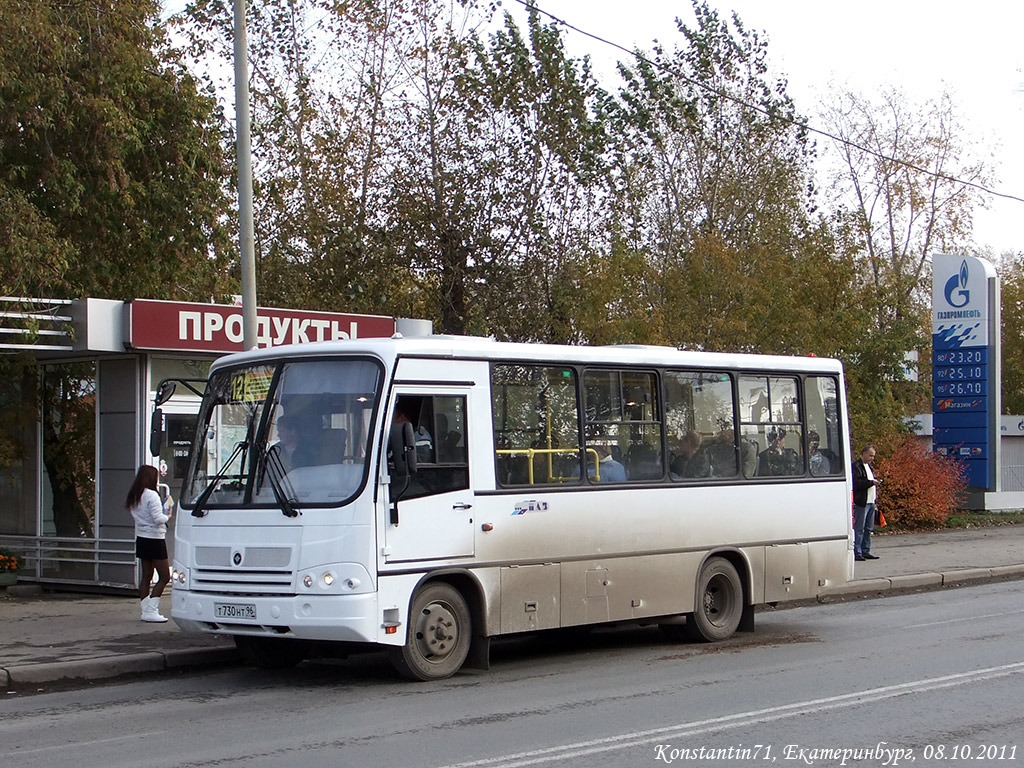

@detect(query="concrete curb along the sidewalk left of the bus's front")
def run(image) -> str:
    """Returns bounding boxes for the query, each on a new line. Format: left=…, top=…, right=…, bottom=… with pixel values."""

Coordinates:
left=0, top=648, right=240, bottom=691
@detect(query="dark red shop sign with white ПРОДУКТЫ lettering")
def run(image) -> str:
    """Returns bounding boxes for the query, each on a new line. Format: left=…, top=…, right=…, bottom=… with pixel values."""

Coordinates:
left=125, top=299, right=395, bottom=352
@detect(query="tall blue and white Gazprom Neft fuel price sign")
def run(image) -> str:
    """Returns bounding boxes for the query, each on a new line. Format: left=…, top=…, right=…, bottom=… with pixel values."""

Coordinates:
left=932, top=254, right=999, bottom=490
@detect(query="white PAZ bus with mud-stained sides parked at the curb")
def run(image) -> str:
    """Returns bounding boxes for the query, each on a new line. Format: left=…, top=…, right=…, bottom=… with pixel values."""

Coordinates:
left=172, top=336, right=853, bottom=680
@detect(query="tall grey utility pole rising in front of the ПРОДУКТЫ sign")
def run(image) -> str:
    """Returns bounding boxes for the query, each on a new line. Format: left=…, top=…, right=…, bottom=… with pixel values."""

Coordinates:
left=234, top=0, right=257, bottom=349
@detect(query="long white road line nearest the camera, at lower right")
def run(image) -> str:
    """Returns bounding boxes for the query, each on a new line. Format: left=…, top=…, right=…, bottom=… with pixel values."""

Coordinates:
left=443, top=662, right=1024, bottom=768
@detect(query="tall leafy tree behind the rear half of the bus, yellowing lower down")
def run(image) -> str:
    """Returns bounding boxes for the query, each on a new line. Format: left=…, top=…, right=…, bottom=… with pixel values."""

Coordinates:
left=610, top=0, right=856, bottom=353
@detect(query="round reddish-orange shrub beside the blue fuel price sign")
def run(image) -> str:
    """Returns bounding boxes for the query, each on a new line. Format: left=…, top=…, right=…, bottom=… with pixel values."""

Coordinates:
left=872, top=435, right=966, bottom=530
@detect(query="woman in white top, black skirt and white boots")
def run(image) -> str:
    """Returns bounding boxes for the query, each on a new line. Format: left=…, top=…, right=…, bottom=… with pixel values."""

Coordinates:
left=125, top=464, right=171, bottom=622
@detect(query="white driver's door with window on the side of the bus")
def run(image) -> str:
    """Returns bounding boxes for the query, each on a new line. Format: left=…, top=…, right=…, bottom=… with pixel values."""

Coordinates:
left=384, top=389, right=474, bottom=562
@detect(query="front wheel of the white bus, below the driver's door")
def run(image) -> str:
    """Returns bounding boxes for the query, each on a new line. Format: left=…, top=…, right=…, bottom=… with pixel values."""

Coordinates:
left=389, top=584, right=472, bottom=681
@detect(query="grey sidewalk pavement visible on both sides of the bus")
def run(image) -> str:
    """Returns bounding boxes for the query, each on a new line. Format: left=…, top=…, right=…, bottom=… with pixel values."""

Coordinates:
left=0, top=525, right=1024, bottom=691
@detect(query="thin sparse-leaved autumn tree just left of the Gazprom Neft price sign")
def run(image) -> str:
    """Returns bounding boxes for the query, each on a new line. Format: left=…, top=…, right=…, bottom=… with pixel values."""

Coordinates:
left=819, top=88, right=993, bottom=450
